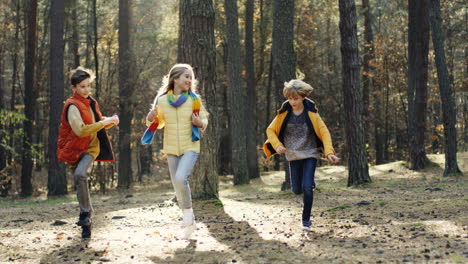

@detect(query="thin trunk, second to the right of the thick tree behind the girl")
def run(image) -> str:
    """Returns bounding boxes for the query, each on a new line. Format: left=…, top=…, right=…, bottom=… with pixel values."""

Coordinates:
left=245, top=0, right=260, bottom=179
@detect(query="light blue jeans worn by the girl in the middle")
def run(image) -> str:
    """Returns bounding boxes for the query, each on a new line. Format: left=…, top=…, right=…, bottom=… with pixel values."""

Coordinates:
left=167, top=151, right=198, bottom=209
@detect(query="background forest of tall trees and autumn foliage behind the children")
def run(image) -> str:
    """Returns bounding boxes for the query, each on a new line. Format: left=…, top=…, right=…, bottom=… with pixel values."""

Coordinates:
left=0, top=0, right=468, bottom=198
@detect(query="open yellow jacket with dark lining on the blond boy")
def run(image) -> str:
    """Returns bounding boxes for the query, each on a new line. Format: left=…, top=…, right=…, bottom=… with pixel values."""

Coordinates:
left=263, top=98, right=335, bottom=157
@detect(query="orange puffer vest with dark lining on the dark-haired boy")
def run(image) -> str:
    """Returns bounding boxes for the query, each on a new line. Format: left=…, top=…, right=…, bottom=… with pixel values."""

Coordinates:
left=57, top=93, right=114, bottom=164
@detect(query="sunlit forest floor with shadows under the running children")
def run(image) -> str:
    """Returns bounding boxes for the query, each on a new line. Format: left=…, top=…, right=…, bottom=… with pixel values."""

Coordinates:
left=0, top=153, right=468, bottom=263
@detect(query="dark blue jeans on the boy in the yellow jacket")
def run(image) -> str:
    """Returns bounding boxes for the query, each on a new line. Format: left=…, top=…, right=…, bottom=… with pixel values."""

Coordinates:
left=289, top=158, right=317, bottom=227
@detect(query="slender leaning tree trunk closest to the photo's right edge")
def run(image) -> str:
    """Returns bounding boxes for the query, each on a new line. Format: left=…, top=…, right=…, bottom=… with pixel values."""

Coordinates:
left=430, top=0, right=461, bottom=177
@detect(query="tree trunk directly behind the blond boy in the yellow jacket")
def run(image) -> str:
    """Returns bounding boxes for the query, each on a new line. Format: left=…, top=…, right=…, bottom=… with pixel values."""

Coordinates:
left=271, top=0, right=296, bottom=190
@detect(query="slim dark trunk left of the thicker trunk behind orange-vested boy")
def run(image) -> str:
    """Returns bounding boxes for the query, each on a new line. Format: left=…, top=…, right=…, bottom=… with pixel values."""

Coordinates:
left=21, top=0, right=37, bottom=196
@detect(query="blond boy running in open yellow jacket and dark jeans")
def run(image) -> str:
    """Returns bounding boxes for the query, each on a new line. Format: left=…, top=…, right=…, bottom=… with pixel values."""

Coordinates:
left=263, top=80, right=340, bottom=231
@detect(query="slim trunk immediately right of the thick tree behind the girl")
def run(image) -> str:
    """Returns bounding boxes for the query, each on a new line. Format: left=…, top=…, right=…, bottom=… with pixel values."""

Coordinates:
left=224, top=0, right=249, bottom=185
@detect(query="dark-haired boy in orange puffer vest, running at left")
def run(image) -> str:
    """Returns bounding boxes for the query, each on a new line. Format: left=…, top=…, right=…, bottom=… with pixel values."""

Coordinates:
left=57, top=67, right=119, bottom=238
